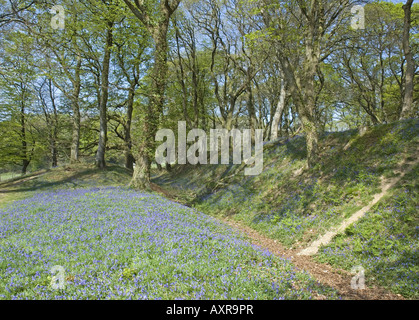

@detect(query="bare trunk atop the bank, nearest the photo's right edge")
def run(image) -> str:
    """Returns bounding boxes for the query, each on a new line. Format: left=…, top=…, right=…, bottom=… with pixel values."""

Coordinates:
left=400, top=0, right=415, bottom=119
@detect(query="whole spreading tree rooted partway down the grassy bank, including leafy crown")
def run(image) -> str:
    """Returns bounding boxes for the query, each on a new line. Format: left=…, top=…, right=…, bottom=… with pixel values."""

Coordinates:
left=260, top=0, right=355, bottom=167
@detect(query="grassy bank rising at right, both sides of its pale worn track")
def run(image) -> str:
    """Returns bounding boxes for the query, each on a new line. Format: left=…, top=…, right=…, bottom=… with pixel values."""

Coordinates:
left=155, top=120, right=419, bottom=297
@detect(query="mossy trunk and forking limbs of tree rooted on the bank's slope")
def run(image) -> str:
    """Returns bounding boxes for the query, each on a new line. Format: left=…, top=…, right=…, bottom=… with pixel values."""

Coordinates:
left=262, top=0, right=334, bottom=168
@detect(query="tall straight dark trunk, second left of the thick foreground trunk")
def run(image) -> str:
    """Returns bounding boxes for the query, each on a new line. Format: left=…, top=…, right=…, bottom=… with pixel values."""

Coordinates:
left=96, top=22, right=113, bottom=169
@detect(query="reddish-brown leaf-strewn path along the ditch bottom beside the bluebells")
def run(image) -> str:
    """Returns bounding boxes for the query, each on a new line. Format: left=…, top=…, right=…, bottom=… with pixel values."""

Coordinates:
left=221, top=218, right=405, bottom=300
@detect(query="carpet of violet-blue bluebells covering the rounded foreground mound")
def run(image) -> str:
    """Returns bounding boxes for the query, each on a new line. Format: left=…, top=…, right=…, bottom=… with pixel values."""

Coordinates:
left=0, top=187, right=339, bottom=299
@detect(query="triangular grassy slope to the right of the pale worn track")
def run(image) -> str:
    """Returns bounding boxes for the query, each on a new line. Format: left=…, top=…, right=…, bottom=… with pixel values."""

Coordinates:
left=318, top=165, right=419, bottom=299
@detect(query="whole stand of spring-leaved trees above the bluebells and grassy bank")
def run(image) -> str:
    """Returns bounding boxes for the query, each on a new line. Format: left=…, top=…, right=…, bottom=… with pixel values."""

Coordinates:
left=0, top=0, right=419, bottom=175
